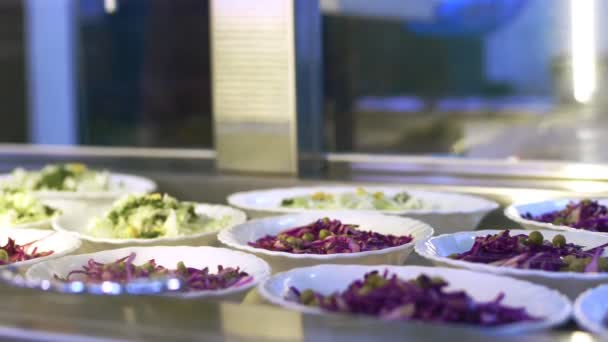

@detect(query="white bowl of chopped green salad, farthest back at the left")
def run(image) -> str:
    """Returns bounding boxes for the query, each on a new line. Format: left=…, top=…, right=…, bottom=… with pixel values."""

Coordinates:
left=0, top=163, right=156, bottom=200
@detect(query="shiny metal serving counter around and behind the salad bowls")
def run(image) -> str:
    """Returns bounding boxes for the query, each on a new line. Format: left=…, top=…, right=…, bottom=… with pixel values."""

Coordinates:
left=0, top=146, right=608, bottom=342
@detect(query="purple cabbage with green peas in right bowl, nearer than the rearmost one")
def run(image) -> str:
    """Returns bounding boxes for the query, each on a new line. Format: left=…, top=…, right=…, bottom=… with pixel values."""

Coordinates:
left=449, top=230, right=608, bottom=273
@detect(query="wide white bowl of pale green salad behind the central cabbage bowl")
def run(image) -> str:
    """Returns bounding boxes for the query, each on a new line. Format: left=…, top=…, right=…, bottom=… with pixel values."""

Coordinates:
left=228, top=185, right=498, bottom=233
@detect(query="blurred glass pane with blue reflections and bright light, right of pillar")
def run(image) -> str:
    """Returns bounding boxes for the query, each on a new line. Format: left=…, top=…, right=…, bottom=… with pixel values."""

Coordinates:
left=324, top=0, right=608, bottom=162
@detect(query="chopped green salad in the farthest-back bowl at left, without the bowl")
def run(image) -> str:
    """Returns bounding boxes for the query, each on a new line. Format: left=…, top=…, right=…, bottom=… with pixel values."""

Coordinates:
left=2, top=163, right=110, bottom=192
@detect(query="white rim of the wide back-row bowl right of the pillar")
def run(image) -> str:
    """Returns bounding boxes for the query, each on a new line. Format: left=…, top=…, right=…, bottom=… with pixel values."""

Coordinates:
left=227, top=185, right=498, bottom=215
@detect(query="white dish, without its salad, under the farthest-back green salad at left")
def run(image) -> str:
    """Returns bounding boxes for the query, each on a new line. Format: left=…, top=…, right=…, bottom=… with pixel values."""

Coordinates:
left=0, top=173, right=157, bottom=200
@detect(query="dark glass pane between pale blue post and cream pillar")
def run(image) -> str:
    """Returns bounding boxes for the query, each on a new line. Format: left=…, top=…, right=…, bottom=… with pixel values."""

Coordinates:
left=78, top=0, right=212, bottom=147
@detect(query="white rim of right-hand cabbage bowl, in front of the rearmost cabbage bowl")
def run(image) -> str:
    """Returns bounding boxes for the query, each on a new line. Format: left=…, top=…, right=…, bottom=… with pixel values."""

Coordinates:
left=414, top=229, right=608, bottom=281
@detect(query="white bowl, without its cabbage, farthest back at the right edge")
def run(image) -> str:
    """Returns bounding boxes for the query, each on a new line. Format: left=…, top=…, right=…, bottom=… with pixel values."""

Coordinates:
left=505, top=198, right=608, bottom=236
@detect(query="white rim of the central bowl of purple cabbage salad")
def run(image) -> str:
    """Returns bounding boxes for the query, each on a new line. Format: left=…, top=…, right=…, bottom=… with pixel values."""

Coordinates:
left=217, top=211, right=435, bottom=260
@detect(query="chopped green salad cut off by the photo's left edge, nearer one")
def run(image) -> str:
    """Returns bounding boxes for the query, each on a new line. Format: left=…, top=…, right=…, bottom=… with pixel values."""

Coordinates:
left=0, top=191, right=58, bottom=225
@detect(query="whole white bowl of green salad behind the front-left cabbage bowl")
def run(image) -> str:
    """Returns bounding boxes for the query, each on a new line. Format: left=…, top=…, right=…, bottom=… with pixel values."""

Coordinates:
left=53, top=194, right=246, bottom=249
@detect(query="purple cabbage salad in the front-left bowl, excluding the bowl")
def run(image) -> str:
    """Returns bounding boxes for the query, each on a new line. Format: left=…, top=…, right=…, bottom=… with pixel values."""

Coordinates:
left=55, top=253, right=253, bottom=291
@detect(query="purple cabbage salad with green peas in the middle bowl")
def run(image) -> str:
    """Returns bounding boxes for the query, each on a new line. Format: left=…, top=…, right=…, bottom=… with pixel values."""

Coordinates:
left=249, top=217, right=414, bottom=254
